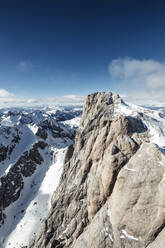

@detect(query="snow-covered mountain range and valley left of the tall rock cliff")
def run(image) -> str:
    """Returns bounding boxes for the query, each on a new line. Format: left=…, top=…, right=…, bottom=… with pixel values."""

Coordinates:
left=0, top=107, right=82, bottom=248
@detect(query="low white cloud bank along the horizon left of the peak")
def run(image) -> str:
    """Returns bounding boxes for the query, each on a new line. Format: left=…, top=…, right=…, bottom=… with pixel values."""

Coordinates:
left=0, top=89, right=85, bottom=108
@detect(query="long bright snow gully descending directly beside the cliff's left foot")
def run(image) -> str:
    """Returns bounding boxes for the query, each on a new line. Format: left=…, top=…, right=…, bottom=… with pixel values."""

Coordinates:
left=0, top=148, right=66, bottom=248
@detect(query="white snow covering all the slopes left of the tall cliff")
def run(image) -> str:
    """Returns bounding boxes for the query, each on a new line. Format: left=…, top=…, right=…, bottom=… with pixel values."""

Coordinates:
left=0, top=109, right=79, bottom=248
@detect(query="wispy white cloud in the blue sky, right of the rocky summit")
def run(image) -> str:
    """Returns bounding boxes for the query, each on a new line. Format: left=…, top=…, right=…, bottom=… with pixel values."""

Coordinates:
left=109, top=58, right=165, bottom=104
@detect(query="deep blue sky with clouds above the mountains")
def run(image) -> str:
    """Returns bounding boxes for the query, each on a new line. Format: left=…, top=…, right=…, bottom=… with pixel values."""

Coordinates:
left=0, top=0, right=165, bottom=107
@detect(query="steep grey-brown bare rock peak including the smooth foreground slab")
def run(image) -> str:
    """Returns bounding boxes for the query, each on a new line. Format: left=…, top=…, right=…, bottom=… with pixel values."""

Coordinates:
left=29, top=93, right=165, bottom=248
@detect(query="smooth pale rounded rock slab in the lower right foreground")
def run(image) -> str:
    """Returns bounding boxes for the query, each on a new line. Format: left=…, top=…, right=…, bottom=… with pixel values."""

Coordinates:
left=73, top=141, right=165, bottom=248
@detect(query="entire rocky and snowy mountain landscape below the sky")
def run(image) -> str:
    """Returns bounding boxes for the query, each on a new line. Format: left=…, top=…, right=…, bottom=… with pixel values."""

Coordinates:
left=0, top=92, right=165, bottom=248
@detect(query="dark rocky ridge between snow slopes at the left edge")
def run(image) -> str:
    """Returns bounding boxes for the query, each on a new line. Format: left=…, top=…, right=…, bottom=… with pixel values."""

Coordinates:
left=0, top=141, right=47, bottom=227
